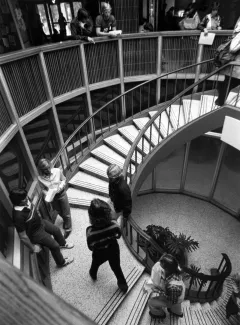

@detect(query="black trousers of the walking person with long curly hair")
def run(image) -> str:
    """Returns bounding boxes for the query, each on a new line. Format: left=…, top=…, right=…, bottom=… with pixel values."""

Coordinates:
left=91, top=240, right=126, bottom=282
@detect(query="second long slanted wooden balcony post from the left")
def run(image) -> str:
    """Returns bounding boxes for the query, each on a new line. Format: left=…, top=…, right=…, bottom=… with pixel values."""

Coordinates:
left=39, top=52, right=68, bottom=166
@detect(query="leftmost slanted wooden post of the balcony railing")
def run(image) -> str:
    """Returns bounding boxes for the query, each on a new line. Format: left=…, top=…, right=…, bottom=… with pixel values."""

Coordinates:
left=0, top=67, right=38, bottom=180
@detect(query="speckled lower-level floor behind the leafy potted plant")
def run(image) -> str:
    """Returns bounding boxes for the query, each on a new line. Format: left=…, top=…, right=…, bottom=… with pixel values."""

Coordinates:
left=133, top=193, right=240, bottom=273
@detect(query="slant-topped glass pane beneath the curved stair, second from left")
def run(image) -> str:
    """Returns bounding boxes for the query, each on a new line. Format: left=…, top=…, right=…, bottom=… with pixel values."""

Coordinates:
left=156, top=145, right=185, bottom=190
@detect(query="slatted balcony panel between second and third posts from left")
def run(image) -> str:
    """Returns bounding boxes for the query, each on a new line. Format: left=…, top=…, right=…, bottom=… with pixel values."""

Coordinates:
left=44, top=46, right=83, bottom=97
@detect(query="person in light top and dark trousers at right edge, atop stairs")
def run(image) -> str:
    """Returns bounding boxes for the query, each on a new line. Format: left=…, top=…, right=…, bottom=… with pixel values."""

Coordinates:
left=215, top=18, right=240, bottom=106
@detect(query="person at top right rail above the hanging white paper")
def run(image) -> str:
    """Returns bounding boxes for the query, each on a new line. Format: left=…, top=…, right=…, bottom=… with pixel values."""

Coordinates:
left=198, top=2, right=222, bottom=35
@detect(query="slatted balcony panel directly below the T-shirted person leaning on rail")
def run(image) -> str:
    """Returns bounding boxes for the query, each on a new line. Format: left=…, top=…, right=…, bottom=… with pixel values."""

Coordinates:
left=85, top=40, right=119, bottom=84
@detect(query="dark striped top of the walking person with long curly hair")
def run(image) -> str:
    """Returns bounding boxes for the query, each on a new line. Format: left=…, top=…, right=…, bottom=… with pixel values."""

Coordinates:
left=86, top=221, right=121, bottom=251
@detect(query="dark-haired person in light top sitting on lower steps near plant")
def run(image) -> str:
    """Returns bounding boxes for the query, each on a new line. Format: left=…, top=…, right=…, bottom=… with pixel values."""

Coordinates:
left=145, top=254, right=185, bottom=319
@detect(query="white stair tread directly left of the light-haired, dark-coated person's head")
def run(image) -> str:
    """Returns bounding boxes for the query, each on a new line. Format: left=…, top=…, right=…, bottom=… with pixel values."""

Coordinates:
left=79, top=157, right=108, bottom=181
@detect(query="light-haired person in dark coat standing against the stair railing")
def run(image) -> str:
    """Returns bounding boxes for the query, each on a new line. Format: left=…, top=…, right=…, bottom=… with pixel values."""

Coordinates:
left=107, top=164, right=132, bottom=219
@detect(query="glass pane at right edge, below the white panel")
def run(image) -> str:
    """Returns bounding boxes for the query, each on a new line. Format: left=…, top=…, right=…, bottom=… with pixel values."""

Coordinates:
left=213, top=146, right=240, bottom=212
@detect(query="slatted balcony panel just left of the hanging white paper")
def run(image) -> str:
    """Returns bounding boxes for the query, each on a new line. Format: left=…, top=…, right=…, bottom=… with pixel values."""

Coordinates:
left=162, top=36, right=199, bottom=73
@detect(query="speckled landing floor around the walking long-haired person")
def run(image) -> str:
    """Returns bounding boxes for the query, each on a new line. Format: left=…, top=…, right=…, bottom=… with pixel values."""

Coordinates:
left=50, top=209, right=142, bottom=319
